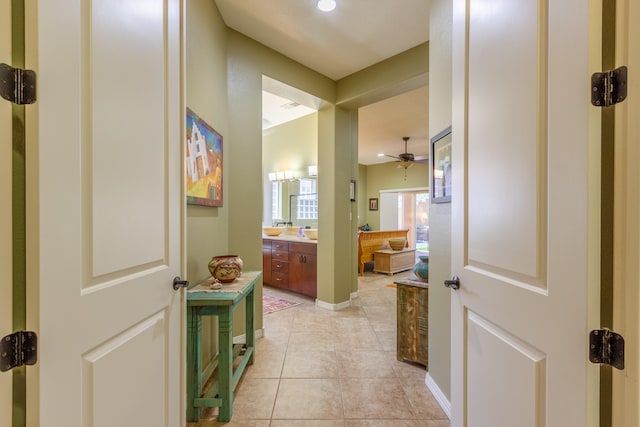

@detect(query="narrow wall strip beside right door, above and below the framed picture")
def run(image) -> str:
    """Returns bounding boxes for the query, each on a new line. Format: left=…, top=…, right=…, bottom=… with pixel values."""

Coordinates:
left=429, top=0, right=455, bottom=400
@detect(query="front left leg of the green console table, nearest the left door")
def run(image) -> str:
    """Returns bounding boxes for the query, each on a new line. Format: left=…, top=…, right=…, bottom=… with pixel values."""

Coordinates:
left=187, top=307, right=202, bottom=421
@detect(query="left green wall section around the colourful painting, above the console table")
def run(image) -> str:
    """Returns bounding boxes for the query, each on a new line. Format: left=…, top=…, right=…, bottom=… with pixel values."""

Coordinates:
left=185, top=0, right=231, bottom=368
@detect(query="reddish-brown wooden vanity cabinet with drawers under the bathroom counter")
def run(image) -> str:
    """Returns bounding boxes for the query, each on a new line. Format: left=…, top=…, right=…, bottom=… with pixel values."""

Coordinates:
left=262, top=239, right=318, bottom=298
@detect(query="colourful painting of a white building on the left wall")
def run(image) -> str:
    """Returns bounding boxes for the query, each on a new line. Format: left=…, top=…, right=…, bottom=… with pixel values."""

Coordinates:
left=186, top=108, right=222, bottom=206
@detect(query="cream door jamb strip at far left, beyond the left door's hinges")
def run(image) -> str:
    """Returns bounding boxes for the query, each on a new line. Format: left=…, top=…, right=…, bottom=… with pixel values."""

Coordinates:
left=0, top=0, right=14, bottom=426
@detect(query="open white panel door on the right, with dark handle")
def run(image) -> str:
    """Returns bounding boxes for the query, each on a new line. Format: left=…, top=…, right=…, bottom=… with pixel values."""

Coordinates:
left=452, top=0, right=599, bottom=427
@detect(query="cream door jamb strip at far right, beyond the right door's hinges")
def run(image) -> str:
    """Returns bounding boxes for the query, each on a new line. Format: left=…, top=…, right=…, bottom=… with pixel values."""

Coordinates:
left=611, top=0, right=640, bottom=427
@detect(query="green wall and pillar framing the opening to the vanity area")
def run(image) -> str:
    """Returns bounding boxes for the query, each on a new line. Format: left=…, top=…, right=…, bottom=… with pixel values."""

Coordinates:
left=225, top=29, right=357, bottom=304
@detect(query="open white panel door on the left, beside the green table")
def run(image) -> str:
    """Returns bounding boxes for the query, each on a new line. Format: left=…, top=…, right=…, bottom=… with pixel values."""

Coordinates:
left=26, top=0, right=185, bottom=427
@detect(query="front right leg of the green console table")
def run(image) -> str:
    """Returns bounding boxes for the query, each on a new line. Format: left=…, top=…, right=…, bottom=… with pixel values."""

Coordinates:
left=218, top=309, right=233, bottom=421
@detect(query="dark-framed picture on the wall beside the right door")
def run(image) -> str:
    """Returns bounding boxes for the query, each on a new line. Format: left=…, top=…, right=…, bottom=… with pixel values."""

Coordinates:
left=431, top=126, right=452, bottom=203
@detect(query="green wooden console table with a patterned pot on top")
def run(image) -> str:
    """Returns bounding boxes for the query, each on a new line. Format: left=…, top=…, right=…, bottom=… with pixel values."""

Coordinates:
left=187, top=271, right=262, bottom=421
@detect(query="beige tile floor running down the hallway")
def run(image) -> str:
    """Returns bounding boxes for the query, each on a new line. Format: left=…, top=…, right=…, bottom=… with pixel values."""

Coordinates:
left=188, top=272, right=449, bottom=427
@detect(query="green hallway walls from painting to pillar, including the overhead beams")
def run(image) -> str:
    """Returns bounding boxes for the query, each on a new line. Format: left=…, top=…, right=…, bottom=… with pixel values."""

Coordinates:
left=185, top=0, right=429, bottom=356
